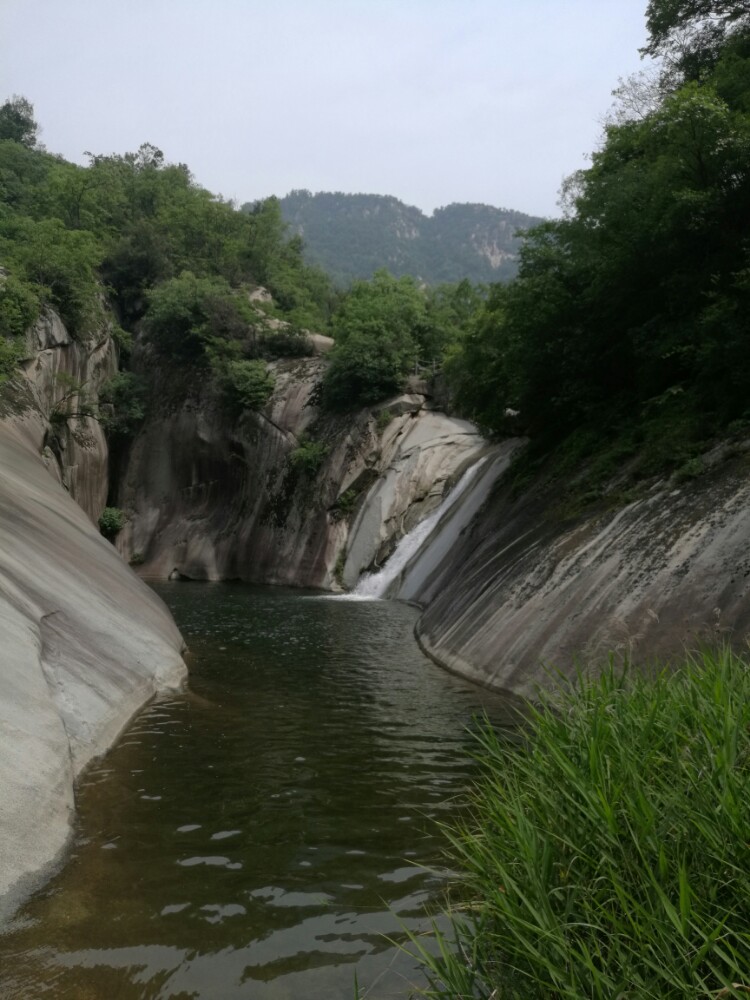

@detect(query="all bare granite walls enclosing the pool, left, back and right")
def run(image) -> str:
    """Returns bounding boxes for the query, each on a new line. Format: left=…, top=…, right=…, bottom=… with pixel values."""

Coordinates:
left=5, top=304, right=750, bottom=920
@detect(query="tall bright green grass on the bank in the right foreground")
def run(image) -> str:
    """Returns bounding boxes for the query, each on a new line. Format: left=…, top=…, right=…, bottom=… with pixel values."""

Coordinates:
left=411, top=649, right=750, bottom=1000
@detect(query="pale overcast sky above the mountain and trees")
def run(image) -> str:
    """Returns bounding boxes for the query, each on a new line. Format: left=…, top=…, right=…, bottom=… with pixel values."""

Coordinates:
left=0, top=0, right=646, bottom=215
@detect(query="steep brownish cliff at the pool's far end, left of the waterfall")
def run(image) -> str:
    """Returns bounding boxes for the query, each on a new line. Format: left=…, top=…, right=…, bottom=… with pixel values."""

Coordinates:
left=118, top=358, right=485, bottom=589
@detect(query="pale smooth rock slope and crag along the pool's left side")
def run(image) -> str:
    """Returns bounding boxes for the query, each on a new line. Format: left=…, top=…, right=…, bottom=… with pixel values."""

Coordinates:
left=0, top=317, right=185, bottom=915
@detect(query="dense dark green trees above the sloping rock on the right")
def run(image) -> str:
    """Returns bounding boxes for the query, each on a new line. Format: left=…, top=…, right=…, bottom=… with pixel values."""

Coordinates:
left=448, top=28, right=750, bottom=444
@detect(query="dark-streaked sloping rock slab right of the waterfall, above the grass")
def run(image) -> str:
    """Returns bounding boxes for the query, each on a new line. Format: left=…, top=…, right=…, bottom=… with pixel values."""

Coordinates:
left=414, top=457, right=750, bottom=695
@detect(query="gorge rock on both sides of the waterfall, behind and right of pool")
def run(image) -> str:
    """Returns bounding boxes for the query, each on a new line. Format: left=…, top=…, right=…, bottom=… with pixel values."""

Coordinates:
left=118, top=350, right=750, bottom=695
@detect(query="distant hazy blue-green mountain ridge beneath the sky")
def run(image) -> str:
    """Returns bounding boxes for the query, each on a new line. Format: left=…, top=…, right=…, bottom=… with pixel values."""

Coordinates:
left=280, top=191, right=542, bottom=285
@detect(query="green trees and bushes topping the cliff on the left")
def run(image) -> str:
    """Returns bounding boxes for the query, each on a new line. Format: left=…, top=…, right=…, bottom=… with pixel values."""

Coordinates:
left=0, top=108, right=336, bottom=406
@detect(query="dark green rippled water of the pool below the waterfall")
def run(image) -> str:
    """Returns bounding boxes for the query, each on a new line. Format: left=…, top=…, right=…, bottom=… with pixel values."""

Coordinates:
left=0, top=583, right=516, bottom=1000
